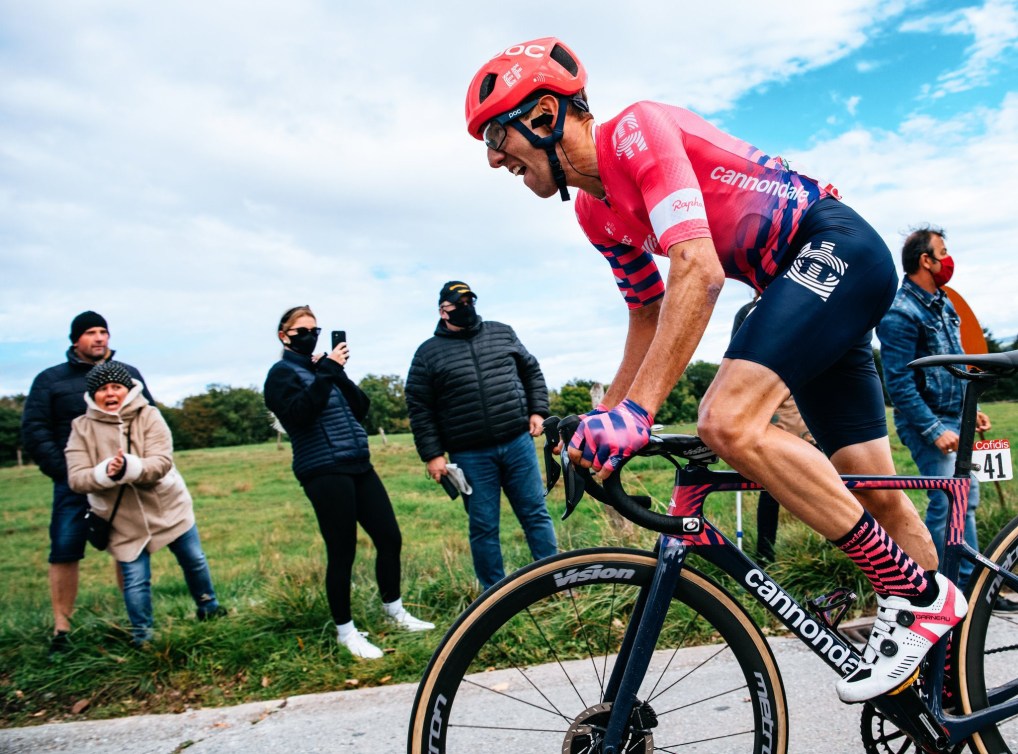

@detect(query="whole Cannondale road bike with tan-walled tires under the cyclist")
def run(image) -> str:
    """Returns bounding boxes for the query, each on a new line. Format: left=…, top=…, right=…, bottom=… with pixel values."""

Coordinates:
left=407, top=351, right=1018, bottom=754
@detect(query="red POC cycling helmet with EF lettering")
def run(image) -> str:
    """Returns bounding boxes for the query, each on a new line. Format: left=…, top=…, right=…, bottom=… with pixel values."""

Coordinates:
left=466, top=37, right=586, bottom=140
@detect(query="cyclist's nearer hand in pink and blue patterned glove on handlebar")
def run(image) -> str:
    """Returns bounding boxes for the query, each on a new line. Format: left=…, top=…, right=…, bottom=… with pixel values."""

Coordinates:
left=569, top=399, right=654, bottom=481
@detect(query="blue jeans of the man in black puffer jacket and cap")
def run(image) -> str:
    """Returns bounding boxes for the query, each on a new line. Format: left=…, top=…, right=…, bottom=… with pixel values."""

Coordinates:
left=449, top=432, right=559, bottom=589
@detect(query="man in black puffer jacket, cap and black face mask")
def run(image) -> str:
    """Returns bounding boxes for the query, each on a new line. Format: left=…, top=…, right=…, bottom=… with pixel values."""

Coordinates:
left=406, top=280, right=558, bottom=589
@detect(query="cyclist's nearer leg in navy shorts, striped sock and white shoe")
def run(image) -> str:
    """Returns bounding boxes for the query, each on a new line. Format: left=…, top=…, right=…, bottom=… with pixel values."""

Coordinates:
left=700, top=202, right=964, bottom=701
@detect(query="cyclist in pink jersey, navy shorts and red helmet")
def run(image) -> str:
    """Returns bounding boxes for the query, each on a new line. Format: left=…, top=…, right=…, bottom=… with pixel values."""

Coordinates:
left=466, top=38, right=966, bottom=702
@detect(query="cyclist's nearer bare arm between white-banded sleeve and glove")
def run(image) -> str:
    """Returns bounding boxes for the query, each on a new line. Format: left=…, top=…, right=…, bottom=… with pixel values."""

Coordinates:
left=627, top=238, right=725, bottom=415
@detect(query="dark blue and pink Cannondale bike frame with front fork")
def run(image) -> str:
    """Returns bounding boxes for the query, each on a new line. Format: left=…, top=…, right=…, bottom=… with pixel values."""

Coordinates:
left=603, top=382, right=1018, bottom=754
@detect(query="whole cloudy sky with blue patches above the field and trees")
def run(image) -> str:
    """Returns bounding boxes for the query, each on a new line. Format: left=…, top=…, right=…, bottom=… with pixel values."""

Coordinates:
left=0, top=0, right=1018, bottom=404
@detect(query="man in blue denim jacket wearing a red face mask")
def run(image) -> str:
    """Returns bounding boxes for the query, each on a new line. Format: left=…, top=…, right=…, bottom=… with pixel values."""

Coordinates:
left=876, top=226, right=989, bottom=586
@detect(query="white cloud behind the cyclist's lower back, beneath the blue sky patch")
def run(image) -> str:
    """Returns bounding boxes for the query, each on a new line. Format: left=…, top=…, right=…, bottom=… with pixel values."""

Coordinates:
left=793, top=93, right=1018, bottom=337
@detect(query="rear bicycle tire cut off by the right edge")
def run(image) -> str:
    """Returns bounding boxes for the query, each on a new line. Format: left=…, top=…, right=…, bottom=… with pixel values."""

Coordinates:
left=958, top=518, right=1018, bottom=754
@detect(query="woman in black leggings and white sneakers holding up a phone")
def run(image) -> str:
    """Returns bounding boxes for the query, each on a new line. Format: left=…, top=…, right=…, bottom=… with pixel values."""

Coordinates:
left=265, top=306, right=435, bottom=659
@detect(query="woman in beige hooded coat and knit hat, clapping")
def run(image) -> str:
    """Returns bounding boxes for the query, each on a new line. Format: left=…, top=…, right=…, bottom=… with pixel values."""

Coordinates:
left=65, top=361, right=222, bottom=645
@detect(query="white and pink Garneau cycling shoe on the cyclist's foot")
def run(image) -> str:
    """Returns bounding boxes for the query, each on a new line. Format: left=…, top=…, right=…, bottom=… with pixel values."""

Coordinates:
left=837, top=574, right=968, bottom=703
